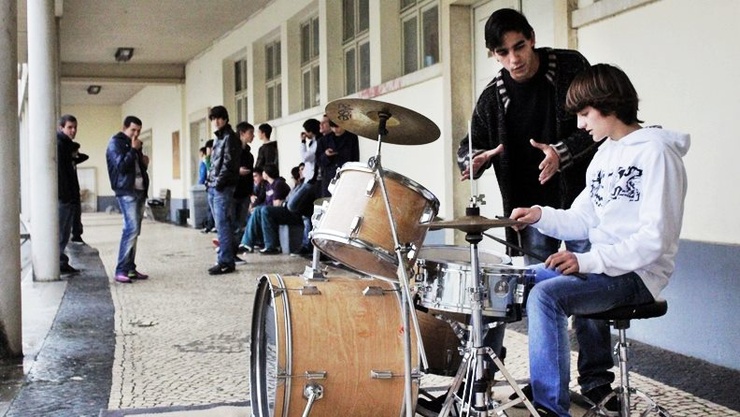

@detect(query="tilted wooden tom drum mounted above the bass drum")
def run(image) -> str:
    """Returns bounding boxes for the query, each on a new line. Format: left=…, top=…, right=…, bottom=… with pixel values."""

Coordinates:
left=313, top=163, right=439, bottom=280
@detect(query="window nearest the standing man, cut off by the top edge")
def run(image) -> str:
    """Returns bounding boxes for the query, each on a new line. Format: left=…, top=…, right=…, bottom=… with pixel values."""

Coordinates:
left=400, top=0, right=439, bottom=74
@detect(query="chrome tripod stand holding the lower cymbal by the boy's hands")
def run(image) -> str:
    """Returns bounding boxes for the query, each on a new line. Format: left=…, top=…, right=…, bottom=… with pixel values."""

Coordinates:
left=439, top=203, right=539, bottom=417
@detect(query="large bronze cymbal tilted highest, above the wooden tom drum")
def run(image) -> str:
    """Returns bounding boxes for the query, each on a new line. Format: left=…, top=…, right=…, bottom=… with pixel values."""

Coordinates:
left=325, top=98, right=439, bottom=145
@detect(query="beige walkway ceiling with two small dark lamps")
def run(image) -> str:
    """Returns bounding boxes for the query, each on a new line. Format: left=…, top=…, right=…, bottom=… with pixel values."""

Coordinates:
left=18, top=0, right=272, bottom=105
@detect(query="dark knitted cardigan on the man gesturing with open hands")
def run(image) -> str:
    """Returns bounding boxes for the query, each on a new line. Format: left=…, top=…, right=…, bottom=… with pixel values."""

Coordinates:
left=457, top=48, right=597, bottom=244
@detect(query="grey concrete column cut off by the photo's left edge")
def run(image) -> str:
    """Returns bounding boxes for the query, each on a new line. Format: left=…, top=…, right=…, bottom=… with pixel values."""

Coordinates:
left=0, top=0, right=23, bottom=358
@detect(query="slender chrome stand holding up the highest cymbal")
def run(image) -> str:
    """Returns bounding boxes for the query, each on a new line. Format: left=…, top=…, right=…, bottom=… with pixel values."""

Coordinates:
left=368, top=112, right=428, bottom=417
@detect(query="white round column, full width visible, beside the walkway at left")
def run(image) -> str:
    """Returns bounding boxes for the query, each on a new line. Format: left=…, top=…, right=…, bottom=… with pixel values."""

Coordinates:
left=28, top=0, right=59, bottom=281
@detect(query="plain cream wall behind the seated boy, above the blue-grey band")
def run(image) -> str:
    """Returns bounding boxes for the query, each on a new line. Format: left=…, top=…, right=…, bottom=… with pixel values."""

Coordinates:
left=578, top=0, right=740, bottom=244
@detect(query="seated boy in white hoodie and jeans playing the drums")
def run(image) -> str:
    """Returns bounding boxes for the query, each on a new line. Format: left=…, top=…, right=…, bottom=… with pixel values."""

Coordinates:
left=511, top=64, right=690, bottom=417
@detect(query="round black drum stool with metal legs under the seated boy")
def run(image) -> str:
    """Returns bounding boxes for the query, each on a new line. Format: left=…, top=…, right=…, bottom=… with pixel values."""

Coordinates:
left=581, top=299, right=671, bottom=417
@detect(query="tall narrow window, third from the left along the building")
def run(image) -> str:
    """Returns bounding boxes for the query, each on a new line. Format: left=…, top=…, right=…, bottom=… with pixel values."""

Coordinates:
left=301, top=16, right=320, bottom=110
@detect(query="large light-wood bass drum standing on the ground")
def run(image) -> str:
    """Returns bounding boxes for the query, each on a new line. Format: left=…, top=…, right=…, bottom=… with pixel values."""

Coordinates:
left=250, top=274, right=419, bottom=417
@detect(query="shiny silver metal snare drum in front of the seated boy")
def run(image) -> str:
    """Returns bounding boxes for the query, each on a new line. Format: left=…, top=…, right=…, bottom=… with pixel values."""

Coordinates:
left=415, top=246, right=534, bottom=321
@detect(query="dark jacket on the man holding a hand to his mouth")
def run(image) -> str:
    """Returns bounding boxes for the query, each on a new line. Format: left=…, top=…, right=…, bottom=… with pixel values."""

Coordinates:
left=105, top=132, right=149, bottom=197
